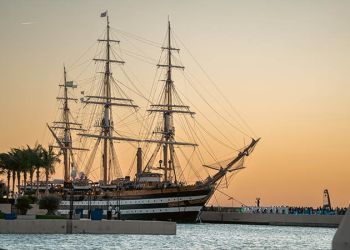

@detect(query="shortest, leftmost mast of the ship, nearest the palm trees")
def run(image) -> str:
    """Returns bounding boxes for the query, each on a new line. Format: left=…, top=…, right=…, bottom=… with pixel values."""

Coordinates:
left=48, top=67, right=86, bottom=182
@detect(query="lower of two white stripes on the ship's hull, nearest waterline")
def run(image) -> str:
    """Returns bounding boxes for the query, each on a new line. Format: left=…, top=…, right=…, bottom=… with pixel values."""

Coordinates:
left=58, top=206, right=202, bottom=215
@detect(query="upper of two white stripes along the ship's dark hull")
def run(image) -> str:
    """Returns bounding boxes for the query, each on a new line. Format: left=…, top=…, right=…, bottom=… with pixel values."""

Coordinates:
left=60, top=195, right=206, bottom=206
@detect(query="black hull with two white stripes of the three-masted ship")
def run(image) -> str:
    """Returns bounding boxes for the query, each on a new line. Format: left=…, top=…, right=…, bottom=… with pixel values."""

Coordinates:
left=58, top=184, right=213, bottom=223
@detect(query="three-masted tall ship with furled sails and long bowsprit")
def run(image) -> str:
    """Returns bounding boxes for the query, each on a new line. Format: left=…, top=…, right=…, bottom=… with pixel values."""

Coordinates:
left=48, top=12, right=259, bottom=222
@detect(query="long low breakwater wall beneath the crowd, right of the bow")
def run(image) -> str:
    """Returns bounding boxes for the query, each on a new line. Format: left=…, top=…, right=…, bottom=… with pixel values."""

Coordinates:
left=200, top=211, right=343, bottom=228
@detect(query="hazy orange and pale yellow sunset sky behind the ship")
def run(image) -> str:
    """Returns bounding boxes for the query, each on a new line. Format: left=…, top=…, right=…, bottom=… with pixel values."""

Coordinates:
left=0, top=0, right=350, bottom=206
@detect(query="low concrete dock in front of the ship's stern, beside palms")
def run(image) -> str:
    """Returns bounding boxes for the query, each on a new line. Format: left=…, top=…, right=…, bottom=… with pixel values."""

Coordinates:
left=0, top=219, right=176, bottom=235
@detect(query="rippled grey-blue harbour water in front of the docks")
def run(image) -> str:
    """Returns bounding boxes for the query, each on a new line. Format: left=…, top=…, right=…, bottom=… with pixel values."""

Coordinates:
left=0, top=224, right=336, bottom=250
